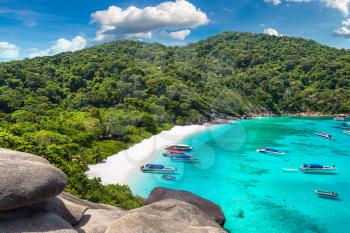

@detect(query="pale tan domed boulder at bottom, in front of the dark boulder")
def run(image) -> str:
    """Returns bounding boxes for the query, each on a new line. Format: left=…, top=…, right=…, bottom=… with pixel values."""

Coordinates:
left=106, top=200, right=226, bottom=233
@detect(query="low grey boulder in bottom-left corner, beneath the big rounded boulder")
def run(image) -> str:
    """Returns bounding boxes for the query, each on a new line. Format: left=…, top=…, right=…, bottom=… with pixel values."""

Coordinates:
left=0, top=210, right=77, bottom=233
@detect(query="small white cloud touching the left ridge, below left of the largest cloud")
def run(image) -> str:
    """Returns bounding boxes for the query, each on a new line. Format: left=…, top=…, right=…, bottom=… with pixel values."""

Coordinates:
left=29, top=36, right=87, bottom=57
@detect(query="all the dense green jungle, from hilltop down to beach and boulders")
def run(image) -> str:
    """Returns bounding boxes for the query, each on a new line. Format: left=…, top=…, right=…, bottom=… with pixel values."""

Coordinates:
left=0, top=32, right=350, bottom=209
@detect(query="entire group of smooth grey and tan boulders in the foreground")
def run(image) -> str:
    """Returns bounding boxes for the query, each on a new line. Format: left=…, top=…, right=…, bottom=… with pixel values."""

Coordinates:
left=0, top=149, right=225, bottom=233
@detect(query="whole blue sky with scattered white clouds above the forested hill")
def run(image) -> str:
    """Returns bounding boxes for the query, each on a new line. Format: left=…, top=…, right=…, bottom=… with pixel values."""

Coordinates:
left=0, top=0, right=350, bottom=61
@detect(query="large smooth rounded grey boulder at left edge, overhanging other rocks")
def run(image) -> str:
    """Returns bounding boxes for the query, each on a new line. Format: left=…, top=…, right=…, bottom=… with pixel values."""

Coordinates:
left=0, top=149, right=67, bottom=211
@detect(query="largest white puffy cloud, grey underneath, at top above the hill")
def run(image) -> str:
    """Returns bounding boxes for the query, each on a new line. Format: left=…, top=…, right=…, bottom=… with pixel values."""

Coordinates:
left=91, top=0, right=209, bottom=41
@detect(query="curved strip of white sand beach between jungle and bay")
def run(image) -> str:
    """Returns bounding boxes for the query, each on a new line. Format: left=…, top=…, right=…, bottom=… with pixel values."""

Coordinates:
left=86, top=125, right=212, bottom=184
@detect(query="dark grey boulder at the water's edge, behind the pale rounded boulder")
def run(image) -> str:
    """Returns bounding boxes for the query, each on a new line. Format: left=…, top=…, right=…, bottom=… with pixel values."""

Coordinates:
left=145, top=188, right=226, bottom=226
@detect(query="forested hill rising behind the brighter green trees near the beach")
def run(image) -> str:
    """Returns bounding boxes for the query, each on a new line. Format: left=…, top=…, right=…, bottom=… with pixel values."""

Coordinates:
left=0, top=32, right=350, bottom=118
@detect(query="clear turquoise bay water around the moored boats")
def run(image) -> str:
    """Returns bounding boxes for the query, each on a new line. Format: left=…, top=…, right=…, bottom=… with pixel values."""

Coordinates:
left=130, top=117, right=350, bottom=233
